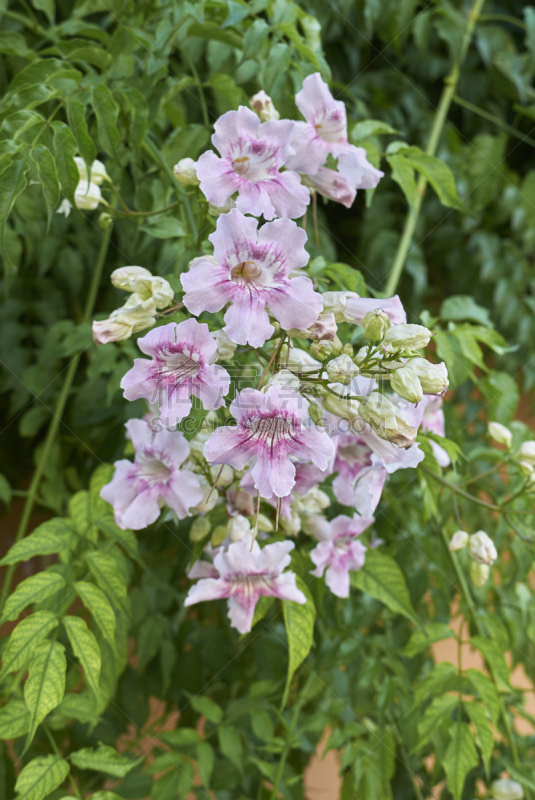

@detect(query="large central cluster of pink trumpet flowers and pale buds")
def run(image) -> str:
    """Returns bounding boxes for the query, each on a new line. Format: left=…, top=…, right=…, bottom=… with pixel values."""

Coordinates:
left=94, top=75, right=456, bottom=633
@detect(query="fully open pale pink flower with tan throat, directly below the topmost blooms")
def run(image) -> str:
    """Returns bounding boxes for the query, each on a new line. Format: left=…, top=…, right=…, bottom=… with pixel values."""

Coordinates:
left=182, top=209, right=322, bottom=347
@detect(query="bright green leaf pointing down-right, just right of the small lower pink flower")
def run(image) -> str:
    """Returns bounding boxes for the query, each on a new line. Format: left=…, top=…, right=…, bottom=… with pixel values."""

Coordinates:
left=351, top=550, right=421, bottom=626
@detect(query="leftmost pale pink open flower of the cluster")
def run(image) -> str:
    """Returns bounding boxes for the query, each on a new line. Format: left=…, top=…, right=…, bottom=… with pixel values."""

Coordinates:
left=100, top=419, right=202, bottom=530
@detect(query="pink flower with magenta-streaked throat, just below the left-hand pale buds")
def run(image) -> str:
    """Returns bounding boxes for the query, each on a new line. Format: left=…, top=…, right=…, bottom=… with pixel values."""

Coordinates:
left=121, top=319, right=230, bottom=427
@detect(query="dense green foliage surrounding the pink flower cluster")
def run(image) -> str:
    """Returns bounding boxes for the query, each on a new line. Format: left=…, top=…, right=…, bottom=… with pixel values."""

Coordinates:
left=0, top=0, right=535, bottom=800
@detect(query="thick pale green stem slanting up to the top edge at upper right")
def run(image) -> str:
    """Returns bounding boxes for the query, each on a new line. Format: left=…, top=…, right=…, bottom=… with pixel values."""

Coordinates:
left=385, top=0, right=485, bottom=297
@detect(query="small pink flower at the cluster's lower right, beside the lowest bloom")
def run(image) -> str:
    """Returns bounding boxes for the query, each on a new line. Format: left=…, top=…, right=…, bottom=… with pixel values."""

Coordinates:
left=308, top=514, right=375, bottom=597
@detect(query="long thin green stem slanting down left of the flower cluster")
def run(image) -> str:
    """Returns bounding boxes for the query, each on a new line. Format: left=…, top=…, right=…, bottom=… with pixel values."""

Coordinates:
left=0, top=222, right=111, bottom=613
